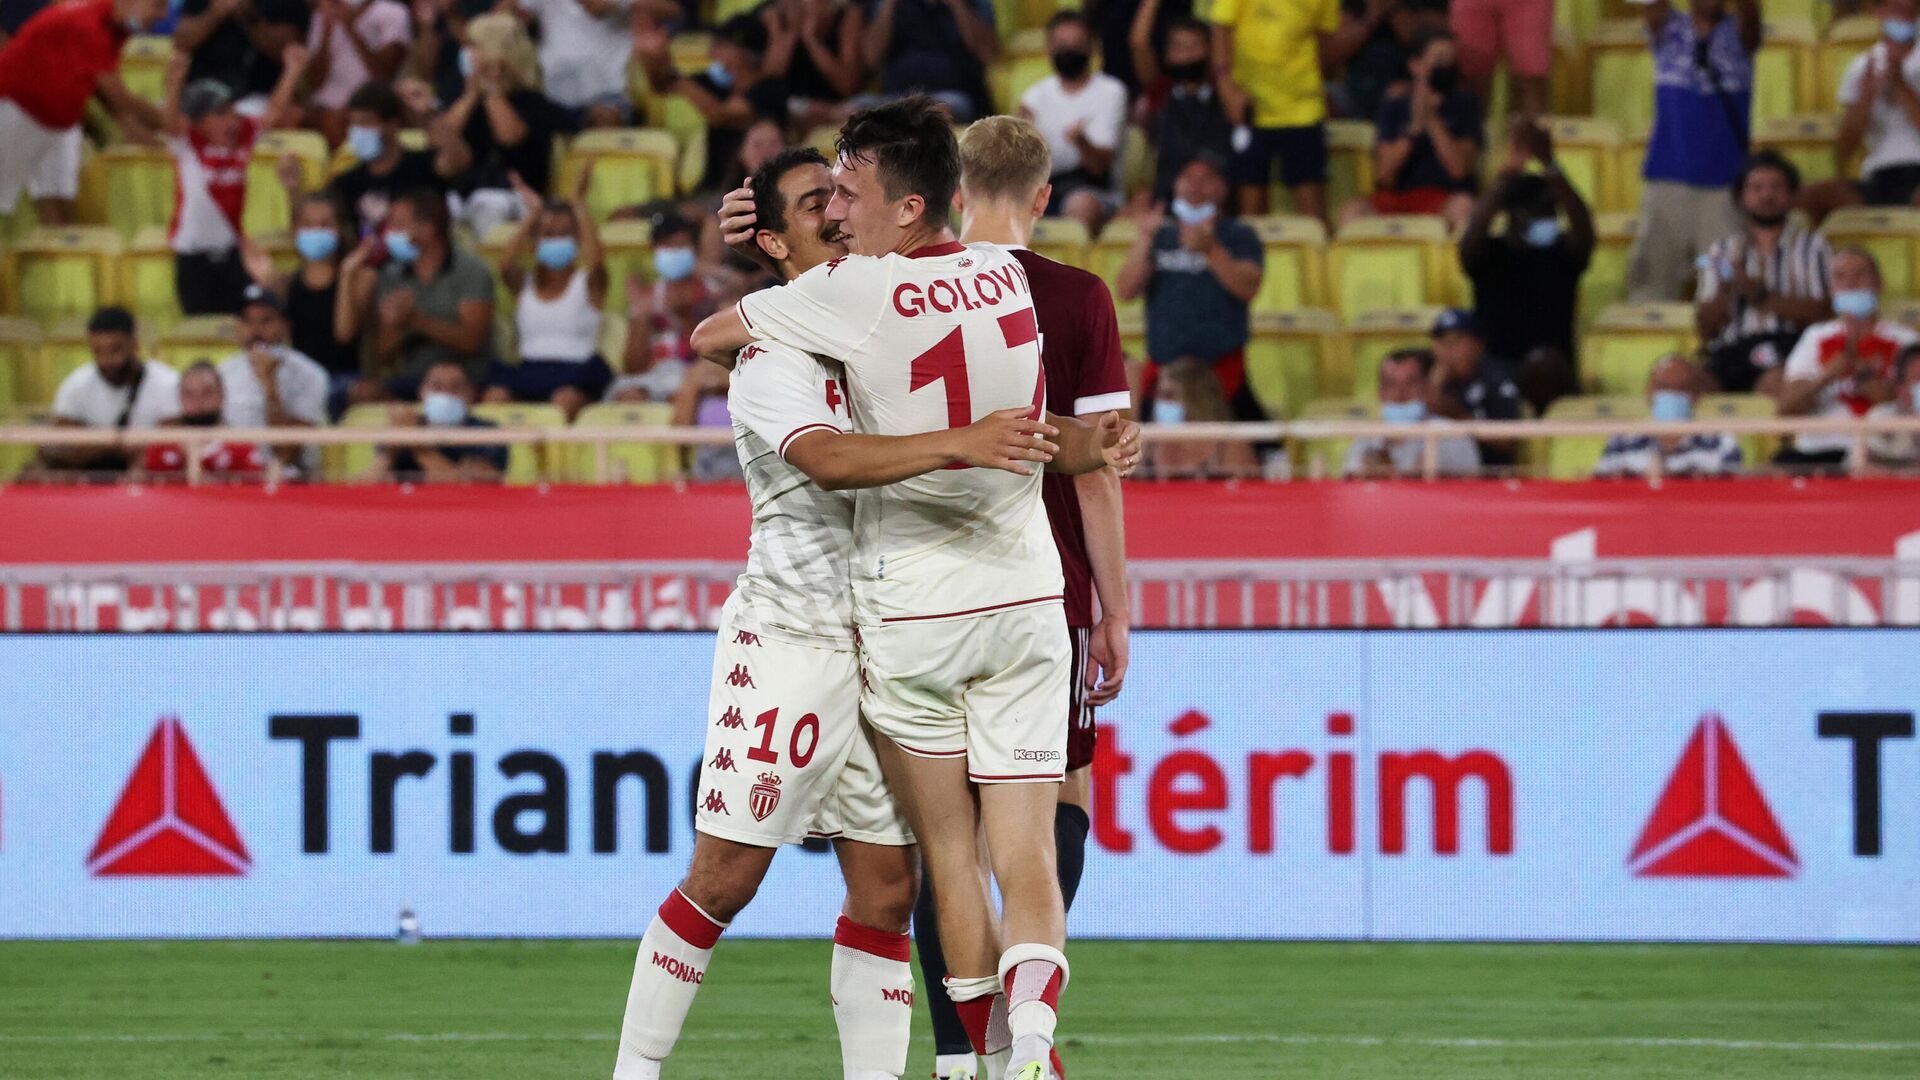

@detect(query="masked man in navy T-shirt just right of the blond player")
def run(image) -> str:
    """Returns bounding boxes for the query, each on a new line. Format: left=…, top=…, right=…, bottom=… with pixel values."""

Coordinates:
left=1117, top=158, right=1265, bottom=421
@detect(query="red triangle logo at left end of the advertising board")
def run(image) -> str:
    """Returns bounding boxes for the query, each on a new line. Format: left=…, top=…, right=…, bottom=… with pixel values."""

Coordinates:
left=86, top=717, right=252, bottom=878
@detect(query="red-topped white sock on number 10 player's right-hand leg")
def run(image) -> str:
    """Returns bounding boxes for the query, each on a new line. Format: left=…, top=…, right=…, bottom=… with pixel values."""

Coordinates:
left=833, top=915, right=914, bottom=1080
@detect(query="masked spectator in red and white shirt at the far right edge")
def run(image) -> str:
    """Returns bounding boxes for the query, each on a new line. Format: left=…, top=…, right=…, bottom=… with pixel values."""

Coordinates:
left=1774, top=248, right=1920, bottom=471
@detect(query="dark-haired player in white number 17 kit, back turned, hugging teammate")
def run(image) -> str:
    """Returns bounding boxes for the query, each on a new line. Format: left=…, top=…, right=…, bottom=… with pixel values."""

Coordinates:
left=693, top=96, right=1071, bottom=1080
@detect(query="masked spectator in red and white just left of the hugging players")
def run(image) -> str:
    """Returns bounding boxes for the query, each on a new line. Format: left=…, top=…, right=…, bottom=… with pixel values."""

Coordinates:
left=607, top=213, right=714, bottom=402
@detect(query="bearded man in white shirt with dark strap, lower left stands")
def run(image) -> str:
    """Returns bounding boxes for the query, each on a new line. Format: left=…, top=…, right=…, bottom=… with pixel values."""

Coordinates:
left=38, top=307, right=180, bottom=475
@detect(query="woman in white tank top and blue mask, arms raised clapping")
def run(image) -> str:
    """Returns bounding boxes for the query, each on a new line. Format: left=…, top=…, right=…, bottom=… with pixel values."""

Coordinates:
left=486, top=169, right=612, bottom=423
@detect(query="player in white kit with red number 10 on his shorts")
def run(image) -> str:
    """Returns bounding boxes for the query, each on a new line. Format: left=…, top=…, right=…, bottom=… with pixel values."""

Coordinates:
left=614, top=150, right=1139, bottom=1080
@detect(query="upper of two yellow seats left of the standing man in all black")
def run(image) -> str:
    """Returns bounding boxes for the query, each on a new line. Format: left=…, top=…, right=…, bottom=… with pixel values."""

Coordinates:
left=1327, top=215, right=1457, bottom=321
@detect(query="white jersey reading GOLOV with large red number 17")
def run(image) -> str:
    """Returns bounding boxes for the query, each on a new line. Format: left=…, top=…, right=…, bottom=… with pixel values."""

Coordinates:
left=739, top=242, right=1062, bottom=625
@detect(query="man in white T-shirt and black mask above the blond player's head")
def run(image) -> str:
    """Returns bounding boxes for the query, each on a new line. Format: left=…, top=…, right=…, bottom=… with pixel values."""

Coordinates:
left=1020, top=12, right=1127, bottom=234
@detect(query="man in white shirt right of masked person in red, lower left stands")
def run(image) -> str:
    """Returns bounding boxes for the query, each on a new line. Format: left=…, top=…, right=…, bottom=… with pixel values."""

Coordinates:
left=219, top=284, right=328, bottom=467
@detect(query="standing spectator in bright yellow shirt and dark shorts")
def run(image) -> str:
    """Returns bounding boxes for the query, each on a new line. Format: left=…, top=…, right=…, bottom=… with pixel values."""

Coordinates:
left=1212, top=0, right=1371, bottom=219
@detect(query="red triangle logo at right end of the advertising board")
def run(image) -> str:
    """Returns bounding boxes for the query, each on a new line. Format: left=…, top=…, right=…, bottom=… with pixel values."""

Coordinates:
left=1626, top=713, right=1799, bottom=878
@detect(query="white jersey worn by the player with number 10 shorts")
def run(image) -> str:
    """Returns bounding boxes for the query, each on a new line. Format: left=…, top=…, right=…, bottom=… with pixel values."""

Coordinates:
left=726, top=342, right=854, bottom=650
